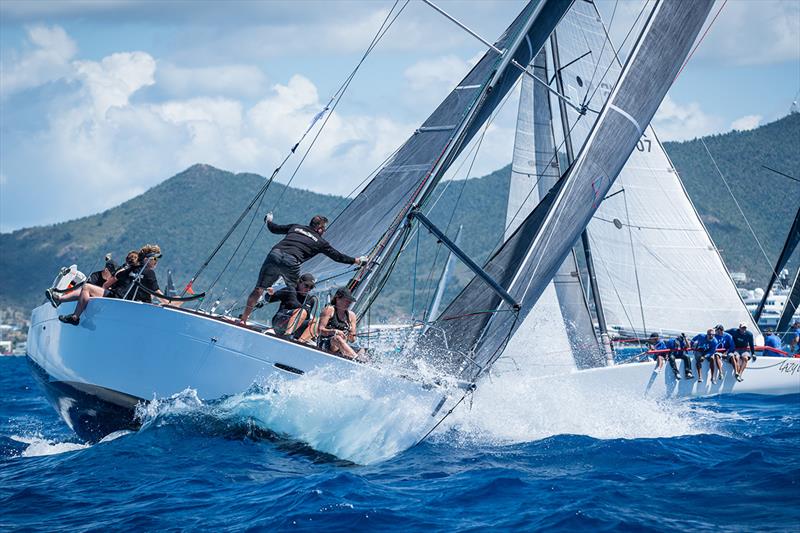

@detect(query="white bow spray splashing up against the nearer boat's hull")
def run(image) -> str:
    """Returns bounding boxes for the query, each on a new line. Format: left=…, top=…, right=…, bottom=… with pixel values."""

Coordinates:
left=137, top=371, right=450, bottom=464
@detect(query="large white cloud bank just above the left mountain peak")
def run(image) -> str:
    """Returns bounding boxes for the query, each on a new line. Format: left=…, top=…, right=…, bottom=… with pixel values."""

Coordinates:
left=3, top=34, right=413, bottom=227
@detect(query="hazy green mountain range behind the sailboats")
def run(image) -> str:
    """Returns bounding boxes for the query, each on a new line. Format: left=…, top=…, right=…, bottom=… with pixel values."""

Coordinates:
left=0, top=114, right=800, bottom=320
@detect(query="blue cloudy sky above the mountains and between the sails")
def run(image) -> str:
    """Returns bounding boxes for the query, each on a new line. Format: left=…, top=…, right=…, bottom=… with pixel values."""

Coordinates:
left=0, top=0, right=800, bottom=231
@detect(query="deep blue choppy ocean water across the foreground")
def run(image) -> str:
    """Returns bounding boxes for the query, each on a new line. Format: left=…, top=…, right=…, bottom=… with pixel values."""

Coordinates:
left=0, top=357, right=800, bottom=531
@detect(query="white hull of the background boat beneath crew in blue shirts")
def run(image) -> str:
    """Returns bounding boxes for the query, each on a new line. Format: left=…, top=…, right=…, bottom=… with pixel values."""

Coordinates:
left=541, top=356, right=800, bottom=398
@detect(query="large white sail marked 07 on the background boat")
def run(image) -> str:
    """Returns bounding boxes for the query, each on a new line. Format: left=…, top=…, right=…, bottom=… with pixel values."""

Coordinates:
left=576, top=2, right=764, bottom=336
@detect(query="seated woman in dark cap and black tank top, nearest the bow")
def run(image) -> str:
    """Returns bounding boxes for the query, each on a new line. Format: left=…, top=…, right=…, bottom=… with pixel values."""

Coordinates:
left=319, top=287, right=368, bottom=362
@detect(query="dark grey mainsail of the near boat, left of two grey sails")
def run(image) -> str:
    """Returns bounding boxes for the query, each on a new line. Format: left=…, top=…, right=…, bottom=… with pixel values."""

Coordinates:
left=306, top=0, right=572, bottom=290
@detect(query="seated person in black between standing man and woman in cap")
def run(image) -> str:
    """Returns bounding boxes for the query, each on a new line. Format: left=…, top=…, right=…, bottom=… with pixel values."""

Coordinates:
left=267, top=273, right=317, bottom=342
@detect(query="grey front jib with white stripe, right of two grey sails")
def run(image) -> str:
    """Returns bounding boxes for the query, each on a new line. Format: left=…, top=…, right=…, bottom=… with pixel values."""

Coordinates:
left=420, top=0, right=713, bottom=379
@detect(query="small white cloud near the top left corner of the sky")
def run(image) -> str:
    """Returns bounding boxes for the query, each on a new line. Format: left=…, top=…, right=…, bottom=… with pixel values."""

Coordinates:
left=0, top=26, right=78, bottom=97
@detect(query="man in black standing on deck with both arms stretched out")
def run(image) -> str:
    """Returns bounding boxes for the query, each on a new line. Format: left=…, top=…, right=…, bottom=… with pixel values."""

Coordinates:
left=240, top=213, right=367, bottom=325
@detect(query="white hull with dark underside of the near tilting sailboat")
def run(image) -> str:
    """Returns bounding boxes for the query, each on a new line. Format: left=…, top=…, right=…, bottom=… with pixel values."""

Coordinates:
left=27, top=298, right=446, bottom=442
